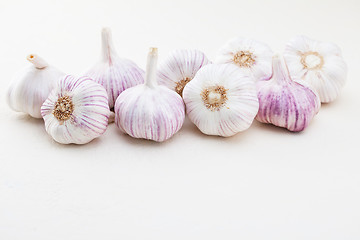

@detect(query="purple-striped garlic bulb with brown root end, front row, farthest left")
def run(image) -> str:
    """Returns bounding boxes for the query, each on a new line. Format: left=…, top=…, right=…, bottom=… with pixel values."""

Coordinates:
left=41, top=75, right=110, bottom=144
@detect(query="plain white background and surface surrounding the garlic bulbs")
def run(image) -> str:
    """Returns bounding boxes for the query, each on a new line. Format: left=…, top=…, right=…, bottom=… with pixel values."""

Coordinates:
left=0, top=0, right=360, bottom=240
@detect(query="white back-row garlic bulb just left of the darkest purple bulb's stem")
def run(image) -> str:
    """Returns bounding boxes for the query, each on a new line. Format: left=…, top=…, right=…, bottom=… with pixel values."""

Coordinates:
left=215, top=37, right=273, bottom=81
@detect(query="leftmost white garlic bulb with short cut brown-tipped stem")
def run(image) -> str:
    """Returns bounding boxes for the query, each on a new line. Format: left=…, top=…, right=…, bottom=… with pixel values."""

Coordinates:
left=6, top=54, right=65, bottom=118
